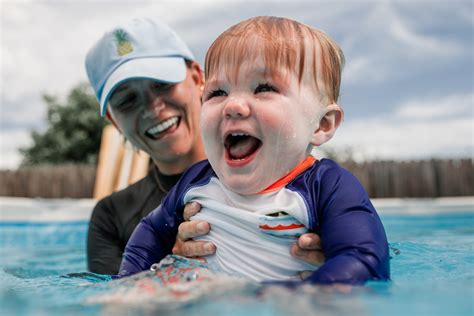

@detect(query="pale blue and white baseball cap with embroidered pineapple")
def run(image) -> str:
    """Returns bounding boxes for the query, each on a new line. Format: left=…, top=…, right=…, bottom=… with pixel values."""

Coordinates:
left=86, top=18, right=195, bottom=116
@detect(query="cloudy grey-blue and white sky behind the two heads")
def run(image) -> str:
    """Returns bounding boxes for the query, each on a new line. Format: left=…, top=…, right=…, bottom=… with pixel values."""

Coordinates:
left=0, top=0, right=474, bottom=169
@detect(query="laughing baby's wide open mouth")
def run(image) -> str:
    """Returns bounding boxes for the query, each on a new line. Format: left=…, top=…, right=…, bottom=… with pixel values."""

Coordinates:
left=224, top=133, right=262, bottom=160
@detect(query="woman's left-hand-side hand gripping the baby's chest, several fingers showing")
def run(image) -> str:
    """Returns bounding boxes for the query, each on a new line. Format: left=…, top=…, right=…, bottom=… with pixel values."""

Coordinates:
left=173, top=202, right=216, bottom=260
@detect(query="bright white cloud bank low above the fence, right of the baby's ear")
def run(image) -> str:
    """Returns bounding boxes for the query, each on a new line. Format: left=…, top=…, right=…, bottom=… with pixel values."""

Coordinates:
left=328, top=93, right=474, bottom=160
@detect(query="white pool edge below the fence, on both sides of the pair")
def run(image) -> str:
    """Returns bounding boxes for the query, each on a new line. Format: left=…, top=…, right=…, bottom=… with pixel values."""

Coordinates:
left=0, top=196, right=474, bottom=222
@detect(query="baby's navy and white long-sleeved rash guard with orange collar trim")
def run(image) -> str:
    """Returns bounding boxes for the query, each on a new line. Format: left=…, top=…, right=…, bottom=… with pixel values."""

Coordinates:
left=120, top=156, right=390, bottom=284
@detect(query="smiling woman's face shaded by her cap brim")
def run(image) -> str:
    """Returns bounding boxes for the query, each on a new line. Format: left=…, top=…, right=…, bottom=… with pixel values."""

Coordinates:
left=109, top=63, right=205, bottom=174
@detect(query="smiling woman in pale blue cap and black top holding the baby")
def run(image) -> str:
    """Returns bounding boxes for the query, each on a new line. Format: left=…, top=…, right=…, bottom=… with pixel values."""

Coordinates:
left=86, top=19, right=324, bottom=274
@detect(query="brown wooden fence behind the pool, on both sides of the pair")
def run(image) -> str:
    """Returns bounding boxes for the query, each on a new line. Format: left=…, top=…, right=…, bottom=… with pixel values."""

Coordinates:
left=0, top=159, right=474, bottom=198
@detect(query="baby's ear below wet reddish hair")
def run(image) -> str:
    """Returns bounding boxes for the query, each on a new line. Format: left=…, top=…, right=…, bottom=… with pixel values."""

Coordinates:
left=311, top=103, right=344, bottom=146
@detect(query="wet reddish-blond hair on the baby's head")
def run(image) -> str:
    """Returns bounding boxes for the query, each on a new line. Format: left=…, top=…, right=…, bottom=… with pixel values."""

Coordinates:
left=205, top=17, right=344, bottom=102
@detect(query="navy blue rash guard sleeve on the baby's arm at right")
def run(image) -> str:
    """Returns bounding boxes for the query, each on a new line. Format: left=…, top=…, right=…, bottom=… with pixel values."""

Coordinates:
left=305, top=160, right=390, bottom=284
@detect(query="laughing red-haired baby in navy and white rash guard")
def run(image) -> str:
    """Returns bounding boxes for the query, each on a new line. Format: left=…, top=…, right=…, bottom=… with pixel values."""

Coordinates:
left=120, top=17, right=390, bottom=284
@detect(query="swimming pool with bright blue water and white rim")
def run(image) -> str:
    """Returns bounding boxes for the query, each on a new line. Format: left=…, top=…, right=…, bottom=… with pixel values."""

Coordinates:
left=0, top=198, right=474, bottom=315
